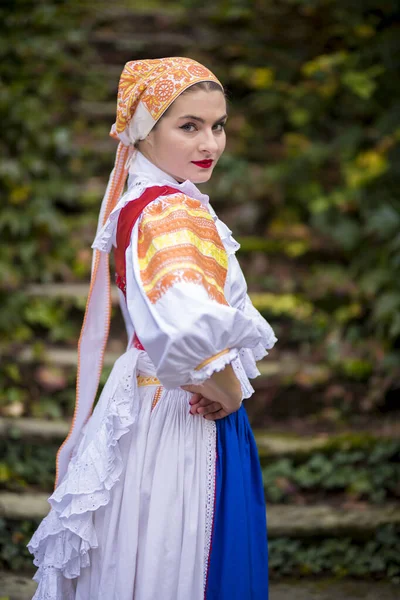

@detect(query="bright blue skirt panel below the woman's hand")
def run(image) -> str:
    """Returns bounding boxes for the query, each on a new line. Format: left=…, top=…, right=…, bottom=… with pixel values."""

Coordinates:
left=205, top=406, right=268, bottom=600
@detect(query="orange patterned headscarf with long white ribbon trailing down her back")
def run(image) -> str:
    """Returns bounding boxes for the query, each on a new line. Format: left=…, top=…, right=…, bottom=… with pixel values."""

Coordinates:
left=55, top=56, right=224, bottom=487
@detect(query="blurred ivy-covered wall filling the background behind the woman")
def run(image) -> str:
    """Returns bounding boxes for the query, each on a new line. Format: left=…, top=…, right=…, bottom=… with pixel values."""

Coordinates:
left=0, top=0, right=400, bottom=589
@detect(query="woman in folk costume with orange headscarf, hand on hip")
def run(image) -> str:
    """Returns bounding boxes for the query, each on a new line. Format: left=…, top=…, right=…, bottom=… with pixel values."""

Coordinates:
left=28, top=57, right=276, bottom=600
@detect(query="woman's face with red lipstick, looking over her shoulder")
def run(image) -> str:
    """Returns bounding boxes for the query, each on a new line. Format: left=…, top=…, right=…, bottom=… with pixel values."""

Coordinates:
left=139, top=90, right=227, bottom=183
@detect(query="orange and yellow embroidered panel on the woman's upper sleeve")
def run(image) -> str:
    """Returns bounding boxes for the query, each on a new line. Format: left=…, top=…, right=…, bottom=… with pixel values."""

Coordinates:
left=138, top=194, right=228, bottom=305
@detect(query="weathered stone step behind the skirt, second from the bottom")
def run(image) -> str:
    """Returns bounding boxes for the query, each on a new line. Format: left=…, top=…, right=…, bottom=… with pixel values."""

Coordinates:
left=0, top=492, right=400, bottom=539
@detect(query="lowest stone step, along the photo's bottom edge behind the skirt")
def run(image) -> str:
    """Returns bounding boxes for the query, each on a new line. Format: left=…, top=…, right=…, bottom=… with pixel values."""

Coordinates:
left=0, top=571, right=400, bottom=600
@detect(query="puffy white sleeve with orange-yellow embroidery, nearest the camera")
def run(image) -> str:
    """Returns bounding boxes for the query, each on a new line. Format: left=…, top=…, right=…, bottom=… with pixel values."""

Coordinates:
left=125, top=193, right=268, bottom=389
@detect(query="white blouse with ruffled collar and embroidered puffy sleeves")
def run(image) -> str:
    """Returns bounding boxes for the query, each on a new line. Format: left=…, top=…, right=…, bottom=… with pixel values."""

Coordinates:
left=92, top=152, right=277, bottom=398
